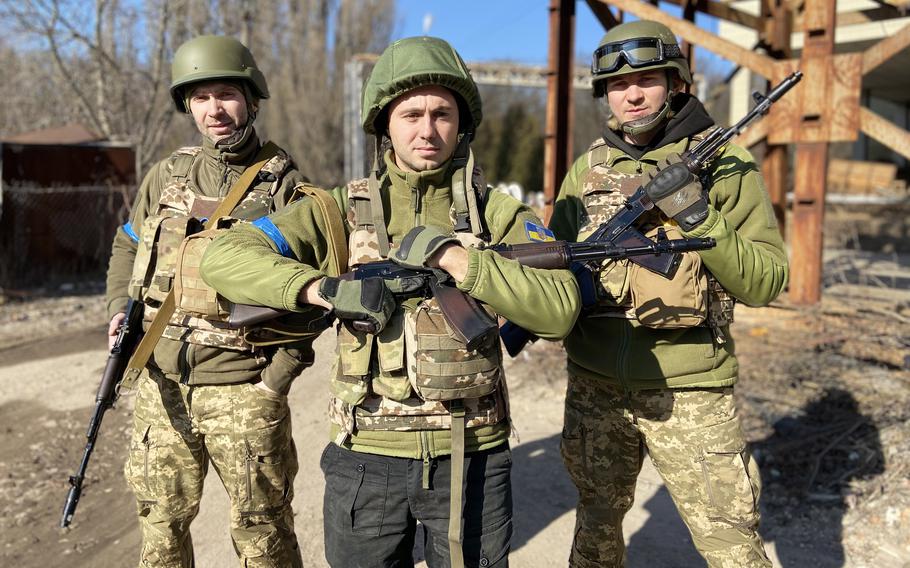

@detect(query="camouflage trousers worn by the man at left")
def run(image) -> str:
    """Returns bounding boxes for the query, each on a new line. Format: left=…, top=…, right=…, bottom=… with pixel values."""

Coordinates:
left=125, top=375, right=302, bottom=568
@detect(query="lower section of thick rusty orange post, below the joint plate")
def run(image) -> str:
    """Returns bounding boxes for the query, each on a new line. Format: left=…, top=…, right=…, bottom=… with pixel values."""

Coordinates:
left=790, top=142, right=828, bottom=305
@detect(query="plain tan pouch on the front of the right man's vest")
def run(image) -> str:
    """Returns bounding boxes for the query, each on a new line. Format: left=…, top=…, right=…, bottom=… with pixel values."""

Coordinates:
left=629, top=226, right=708, bottom=329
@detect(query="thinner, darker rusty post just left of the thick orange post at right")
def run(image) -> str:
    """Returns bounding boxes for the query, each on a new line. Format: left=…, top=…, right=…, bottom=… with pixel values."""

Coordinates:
left=761, top=0, right=793, bottom=238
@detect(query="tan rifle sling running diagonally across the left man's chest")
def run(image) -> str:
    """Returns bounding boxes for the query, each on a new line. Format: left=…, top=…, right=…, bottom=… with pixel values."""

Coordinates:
left=120, top=142, right=279, bottom=389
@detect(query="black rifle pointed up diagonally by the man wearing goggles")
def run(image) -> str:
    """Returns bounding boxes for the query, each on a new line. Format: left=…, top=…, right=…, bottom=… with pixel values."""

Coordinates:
left=500, top=71, right=803, bottom=357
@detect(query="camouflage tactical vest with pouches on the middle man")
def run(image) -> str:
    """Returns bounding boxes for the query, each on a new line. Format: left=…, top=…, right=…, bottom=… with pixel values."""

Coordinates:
left=330, top=172, right=508, bottom=443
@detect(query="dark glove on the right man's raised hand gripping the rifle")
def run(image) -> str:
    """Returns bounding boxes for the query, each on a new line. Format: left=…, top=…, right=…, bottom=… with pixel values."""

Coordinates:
left=648, top=154, right=708, bottom=231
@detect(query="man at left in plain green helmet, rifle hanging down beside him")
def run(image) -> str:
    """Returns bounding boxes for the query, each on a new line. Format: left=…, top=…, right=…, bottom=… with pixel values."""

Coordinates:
left=107, top=36, right=313, bottom=568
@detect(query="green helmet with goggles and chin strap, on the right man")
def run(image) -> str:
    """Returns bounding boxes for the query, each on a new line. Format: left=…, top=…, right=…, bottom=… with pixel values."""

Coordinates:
left=591, top=20, right=692, bottom=135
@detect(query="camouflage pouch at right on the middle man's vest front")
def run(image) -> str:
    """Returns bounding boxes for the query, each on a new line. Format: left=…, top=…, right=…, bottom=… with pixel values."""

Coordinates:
left=405, top=298, right=502, bottom=401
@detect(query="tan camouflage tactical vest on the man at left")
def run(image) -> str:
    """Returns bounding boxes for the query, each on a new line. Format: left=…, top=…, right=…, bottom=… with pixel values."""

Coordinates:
left=129, top=146, right=290, bottom=351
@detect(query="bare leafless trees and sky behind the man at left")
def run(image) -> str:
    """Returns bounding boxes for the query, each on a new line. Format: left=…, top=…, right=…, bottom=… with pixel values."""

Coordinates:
left=0, top=0, right=394, bottom=184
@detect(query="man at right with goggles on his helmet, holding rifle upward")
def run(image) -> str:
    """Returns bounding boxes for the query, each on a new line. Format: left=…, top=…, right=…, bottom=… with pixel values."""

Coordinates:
left=550, top=21, right=788, bottom=568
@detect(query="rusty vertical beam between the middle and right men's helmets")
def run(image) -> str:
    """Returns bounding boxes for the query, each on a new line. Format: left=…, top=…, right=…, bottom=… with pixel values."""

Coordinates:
left=543, top=0, right=575, bottom=222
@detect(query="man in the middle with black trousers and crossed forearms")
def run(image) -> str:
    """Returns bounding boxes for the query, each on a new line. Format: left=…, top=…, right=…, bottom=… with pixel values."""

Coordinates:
left=202, top=37, right=579, bottom=568
